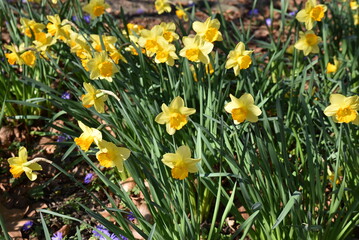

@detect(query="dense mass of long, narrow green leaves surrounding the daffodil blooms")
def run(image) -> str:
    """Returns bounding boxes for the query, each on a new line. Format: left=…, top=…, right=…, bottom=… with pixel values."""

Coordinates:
left=0, top=0, right=359, bottom=240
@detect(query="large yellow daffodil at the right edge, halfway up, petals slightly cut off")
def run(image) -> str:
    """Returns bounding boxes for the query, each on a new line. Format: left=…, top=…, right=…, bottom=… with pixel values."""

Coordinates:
left=324, top=94, right=359, bottom=125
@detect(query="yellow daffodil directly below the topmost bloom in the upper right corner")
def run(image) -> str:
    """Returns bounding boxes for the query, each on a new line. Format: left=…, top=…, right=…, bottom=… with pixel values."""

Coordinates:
left=294, top=30, right=322, bottom=56
